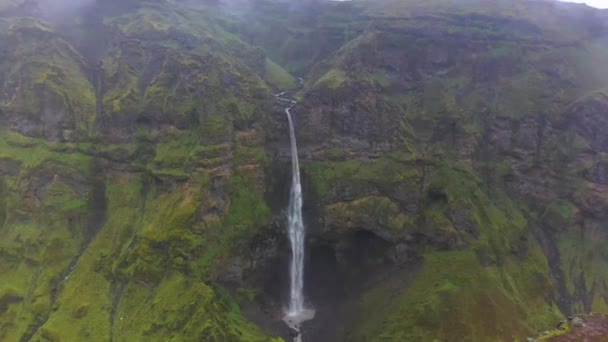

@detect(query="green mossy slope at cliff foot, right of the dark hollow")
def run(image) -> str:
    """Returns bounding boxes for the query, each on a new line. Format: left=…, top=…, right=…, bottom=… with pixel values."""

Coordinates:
left=347, top=251, right=562, bottom=341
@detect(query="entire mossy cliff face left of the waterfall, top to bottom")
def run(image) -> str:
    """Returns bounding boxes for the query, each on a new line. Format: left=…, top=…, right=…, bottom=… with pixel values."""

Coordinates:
left=0, top=2, right=282, bottom=341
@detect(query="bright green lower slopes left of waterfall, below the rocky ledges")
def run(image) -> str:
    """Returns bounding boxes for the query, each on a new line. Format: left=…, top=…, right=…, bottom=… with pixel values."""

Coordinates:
left=0, top=94, right=270, bottom=341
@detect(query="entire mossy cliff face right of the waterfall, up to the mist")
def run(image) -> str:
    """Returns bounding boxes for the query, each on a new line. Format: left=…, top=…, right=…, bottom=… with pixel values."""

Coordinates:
left=286, top=2, right=608, bottom=341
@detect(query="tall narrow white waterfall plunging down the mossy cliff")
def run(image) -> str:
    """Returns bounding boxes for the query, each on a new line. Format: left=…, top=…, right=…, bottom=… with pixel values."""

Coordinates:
left=285, top=107, right=305, bottom=316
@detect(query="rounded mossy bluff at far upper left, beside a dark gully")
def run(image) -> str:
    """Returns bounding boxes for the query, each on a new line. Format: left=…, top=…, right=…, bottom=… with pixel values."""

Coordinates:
left=0, top=18, right=95, bottom=139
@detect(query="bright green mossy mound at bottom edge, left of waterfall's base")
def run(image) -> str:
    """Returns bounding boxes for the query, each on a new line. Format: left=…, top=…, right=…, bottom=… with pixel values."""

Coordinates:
left=115, top=273, right=280, bottom=342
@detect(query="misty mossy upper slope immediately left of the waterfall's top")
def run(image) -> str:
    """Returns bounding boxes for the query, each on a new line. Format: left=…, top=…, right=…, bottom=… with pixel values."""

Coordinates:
left=103, top=4, right=276, bottom=132
